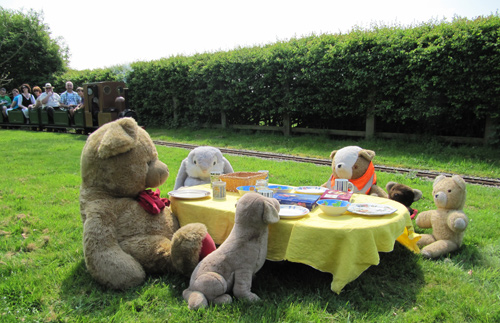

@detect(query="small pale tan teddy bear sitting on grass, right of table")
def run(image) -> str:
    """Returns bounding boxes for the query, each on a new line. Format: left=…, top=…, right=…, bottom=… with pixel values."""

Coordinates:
left=415, top=175, right=469, bottom=258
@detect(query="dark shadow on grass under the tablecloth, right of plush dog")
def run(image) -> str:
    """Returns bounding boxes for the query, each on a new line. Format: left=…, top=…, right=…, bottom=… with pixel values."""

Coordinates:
left=254, top=243, right=425, bottom=313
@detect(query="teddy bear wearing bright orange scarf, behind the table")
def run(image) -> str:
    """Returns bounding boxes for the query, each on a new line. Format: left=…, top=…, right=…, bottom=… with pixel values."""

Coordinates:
left=323, top=146, right=387, bottom=197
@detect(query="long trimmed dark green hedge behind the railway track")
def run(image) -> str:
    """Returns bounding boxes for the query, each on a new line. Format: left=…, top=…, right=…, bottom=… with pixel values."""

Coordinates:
left=59, top=13, right=500, bottom=142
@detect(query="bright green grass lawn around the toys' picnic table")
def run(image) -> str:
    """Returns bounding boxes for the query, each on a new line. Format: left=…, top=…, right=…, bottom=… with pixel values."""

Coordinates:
left=0, top=130, right=500, bottom=322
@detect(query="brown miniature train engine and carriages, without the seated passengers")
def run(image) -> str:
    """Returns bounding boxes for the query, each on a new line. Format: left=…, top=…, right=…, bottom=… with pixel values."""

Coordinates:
left=0, top=82, right=137, bottom=134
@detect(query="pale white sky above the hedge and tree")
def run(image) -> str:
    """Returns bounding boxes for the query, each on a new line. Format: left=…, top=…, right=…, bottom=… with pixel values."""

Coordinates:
left=0, top=0, right=500, bottom=70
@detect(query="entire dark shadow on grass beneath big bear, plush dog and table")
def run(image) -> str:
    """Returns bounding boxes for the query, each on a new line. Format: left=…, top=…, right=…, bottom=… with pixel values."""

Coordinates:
left=56, top=243, right=424, bottom=319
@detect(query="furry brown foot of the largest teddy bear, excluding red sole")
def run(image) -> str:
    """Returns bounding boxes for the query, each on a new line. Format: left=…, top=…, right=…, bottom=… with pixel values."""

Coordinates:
left=171, top=223, right=215, bottom=276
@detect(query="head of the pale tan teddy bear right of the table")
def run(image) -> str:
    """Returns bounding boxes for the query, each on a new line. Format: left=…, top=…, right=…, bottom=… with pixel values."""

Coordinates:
left=432, top=175, right=467, bottom=210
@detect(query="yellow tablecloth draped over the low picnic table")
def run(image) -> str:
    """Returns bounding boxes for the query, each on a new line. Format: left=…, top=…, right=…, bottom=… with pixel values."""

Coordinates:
left=170, top=184, right=420, bottom=293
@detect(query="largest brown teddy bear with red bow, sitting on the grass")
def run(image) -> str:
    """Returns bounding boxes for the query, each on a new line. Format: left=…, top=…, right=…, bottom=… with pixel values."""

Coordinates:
left=80, top=118, right=215, bottom=289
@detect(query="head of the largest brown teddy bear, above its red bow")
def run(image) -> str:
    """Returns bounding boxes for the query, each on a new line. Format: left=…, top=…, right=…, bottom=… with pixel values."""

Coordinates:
left=81, top=118, right=169, bottom=198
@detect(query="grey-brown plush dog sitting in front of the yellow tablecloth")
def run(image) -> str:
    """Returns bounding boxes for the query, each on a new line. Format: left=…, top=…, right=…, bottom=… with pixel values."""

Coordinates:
left=182, top=193, right=280, bottom=309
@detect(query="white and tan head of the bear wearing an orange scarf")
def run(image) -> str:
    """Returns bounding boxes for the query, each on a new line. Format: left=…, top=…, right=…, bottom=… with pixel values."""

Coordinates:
left=330, top=146, right=375, bottom=179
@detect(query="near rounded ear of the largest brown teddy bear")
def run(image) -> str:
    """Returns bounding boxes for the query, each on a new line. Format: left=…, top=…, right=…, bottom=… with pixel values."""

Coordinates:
left=97, top=118, right=137, bottom=159
